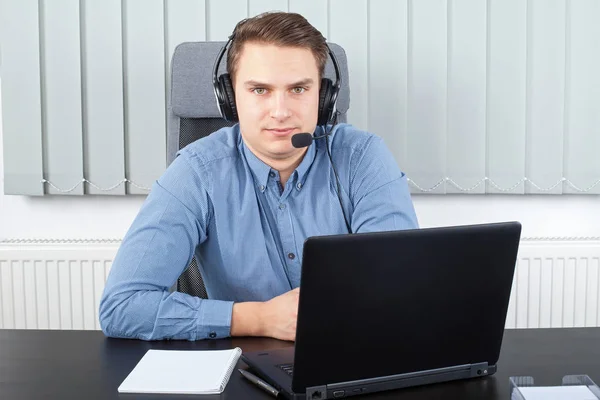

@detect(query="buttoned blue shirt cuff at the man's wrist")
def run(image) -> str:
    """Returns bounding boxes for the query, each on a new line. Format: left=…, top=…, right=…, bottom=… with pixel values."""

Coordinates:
left=196, top=300, right=233, bottom=339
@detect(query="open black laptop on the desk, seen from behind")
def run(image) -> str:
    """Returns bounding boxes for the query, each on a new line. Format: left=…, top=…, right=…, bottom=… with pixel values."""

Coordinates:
left=242, top=222, right=521, bottom=400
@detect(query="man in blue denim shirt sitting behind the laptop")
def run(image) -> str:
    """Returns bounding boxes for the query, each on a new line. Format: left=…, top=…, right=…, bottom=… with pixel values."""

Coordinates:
left=100, top=13, right=417, bottom=340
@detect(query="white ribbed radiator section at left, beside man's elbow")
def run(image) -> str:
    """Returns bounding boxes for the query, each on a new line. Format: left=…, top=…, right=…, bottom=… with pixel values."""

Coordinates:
left=0, top=240, right=119, bottom=330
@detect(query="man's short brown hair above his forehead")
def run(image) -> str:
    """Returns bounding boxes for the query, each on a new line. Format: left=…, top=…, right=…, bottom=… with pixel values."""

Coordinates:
left=227, top=12, right=329, bottom=80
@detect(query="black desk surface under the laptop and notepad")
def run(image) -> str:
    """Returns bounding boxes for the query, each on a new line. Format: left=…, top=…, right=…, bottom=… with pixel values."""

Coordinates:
left=0, top=328, right=600, bottom=400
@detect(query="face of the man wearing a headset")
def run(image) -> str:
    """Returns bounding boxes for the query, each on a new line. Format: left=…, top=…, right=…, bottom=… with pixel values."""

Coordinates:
left=234, top=43, right=320, bottom=164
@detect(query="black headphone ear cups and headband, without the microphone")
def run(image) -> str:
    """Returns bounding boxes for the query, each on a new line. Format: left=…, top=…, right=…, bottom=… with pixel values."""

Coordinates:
left=213, top=21, right=342, bottom=126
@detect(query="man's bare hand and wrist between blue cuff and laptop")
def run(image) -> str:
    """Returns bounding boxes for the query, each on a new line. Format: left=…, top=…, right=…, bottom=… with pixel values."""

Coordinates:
left=231, top=288, right=300, bottom=341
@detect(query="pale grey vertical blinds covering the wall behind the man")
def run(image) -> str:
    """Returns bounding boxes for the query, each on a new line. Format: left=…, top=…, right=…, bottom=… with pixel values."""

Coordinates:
left=0, top=0, right=600, bottom=195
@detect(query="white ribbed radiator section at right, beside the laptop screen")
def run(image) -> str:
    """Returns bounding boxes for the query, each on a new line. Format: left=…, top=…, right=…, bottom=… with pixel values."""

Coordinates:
left=506, top=238, right=600, bottom=328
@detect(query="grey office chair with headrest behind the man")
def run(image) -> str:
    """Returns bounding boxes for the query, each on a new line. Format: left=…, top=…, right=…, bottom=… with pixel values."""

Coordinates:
left=167, top=42, right=350, bottom=299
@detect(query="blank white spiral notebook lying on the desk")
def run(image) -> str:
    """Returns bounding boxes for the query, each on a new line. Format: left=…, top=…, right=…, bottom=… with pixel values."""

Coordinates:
left=118, top=347, right=242, bottom=394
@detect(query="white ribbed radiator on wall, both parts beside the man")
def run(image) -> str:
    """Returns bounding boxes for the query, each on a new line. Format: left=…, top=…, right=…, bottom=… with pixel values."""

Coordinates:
left=0, top=238, right=600, bottom=330
